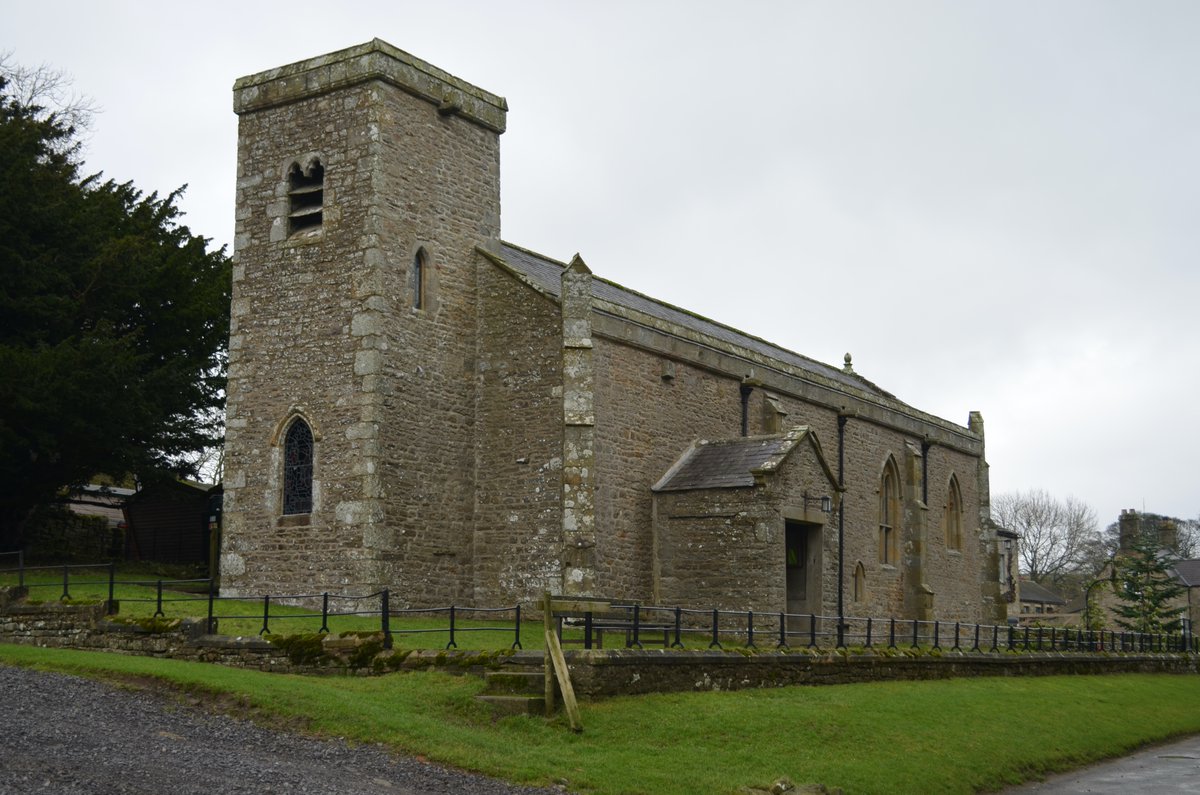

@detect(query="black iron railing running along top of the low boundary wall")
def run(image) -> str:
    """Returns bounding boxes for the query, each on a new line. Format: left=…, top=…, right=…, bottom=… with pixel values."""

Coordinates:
left=0, top=552, right=1200, bottom=653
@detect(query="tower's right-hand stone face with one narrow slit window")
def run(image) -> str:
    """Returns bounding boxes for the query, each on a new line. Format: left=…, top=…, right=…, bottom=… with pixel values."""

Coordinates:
left=372, top=85, right=500, bottom=604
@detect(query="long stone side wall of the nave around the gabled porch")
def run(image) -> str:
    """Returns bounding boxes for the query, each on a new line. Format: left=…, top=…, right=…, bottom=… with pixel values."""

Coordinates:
left=595, top=336, right=996, bottom=621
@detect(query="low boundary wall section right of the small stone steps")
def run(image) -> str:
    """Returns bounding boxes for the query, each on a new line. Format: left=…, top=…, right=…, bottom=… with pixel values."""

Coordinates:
left=565, top=648, right=1200, bottom=698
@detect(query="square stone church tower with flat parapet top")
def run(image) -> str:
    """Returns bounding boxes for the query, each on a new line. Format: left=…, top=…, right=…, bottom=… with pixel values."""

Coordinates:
left=221, top=40, right=508, bottom=604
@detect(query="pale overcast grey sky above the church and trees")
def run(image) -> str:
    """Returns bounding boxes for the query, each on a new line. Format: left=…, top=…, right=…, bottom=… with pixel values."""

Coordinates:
left=0, top=0, right=1200, bottom=526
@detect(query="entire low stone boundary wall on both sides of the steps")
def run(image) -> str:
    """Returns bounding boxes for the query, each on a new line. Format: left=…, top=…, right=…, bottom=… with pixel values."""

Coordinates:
left=0, top=588, right=1200, bottom=699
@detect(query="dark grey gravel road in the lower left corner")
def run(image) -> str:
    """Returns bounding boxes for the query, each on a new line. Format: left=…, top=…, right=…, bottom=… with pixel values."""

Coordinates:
left=0, top=665, right=560, bottom=795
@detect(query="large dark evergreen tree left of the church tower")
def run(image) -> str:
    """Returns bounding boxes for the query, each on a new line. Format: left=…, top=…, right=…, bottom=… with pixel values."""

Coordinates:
left=0, top=64, right=229, bottom=550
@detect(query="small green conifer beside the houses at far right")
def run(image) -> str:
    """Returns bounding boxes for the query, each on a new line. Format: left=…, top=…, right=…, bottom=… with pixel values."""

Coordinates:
left=1112, top=532, right=1184, bottom=633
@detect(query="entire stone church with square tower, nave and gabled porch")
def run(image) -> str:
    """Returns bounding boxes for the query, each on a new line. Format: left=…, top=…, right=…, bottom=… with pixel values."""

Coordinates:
left=221, top=40, right=1004, bottom=621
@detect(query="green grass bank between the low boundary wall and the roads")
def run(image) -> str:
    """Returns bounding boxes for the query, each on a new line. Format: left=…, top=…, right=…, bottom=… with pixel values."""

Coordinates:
left=0, top=645, right=1200, bottom=795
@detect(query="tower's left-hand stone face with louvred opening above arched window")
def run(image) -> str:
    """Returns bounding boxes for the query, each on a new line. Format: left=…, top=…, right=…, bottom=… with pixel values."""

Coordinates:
left=221, top=86, right=371, bottom=594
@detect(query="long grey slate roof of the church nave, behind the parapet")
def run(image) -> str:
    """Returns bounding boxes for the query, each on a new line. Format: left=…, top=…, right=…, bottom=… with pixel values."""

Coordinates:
left=500, top=243, right=895, bottom=398
